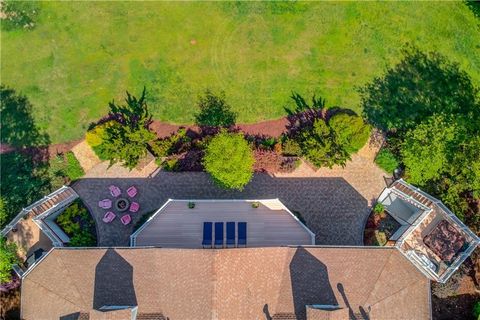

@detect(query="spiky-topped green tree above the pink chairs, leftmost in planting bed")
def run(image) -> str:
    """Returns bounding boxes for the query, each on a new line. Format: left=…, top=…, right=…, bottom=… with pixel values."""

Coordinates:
left=96, top=88, right=156, bottom=170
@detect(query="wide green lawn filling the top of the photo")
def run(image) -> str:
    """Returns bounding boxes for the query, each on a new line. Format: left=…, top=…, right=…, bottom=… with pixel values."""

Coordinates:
left=1, top=2, right=480, bottom=143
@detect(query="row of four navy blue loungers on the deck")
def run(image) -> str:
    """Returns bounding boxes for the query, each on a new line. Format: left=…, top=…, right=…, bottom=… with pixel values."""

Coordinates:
left=202, top=222, right=247, bottom=248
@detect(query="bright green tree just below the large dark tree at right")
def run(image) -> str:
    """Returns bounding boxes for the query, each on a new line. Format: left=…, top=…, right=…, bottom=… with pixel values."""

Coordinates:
left=401, top=116, right=459, bottom=186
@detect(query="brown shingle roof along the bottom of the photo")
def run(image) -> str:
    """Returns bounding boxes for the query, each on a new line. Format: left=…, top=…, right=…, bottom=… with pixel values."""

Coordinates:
left=22, top=247, right=429, bottom=320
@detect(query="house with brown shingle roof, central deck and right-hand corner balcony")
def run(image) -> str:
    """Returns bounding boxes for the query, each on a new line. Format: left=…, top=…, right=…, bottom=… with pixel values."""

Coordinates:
left=13, top=180, right=480, bottom=320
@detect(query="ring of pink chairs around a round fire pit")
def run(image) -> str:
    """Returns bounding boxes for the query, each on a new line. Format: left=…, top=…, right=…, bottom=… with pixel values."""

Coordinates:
left=98, top=185, right=140, bottom=225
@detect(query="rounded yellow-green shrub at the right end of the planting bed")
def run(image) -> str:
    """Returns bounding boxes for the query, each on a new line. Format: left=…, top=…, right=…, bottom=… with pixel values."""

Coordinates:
left=328, top=113, right=371, bottom=154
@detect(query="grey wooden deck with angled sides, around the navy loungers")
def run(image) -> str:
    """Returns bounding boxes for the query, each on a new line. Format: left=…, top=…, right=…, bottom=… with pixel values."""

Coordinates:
left=135, top=200, right=314, bottom=248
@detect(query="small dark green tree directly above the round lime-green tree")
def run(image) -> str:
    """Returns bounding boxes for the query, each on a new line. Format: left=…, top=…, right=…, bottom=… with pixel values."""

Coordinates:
left=195, top=90, right=237, bottom=127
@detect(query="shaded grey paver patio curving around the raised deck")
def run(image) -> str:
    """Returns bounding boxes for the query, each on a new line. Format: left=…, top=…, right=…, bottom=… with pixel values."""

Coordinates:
left=73, top=172, right=380, bottom=246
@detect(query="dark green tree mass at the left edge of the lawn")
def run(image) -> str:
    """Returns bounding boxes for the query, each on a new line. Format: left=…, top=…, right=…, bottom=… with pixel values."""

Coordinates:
left=0, top=86, right=51, bottom=227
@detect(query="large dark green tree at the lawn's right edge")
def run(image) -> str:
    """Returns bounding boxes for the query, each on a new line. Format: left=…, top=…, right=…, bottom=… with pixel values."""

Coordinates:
left=359, top=45, right=480, bottom=132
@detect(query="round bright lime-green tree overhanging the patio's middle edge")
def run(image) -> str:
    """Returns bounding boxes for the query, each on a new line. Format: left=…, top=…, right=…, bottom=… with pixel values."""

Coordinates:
left=203, top=131, right=255, bottom=190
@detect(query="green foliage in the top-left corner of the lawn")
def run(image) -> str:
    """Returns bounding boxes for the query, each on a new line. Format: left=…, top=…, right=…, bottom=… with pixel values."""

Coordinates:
left=0, top=0, right=40, bottom=30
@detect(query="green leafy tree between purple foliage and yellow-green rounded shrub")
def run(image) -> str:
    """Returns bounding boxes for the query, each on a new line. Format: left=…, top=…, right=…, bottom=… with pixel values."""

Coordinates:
left=295, top=119, right=350, bottom=168
